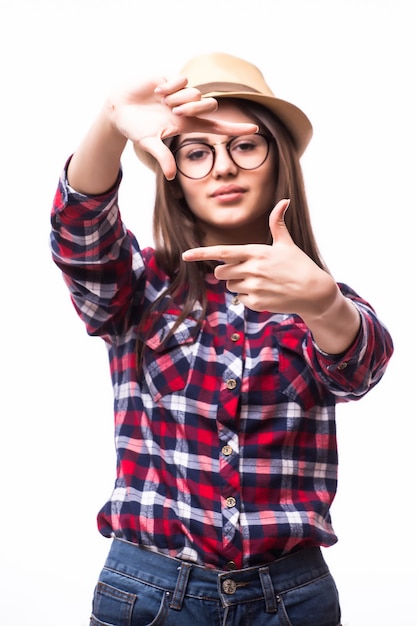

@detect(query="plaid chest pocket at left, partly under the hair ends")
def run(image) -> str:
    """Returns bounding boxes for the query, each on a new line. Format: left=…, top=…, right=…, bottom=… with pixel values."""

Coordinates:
left=141, top=312, right=198, bottom=402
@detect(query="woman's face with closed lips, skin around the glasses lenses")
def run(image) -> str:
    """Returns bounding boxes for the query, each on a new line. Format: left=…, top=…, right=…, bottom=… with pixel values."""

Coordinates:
left=177, top=100, right=277, bottom=245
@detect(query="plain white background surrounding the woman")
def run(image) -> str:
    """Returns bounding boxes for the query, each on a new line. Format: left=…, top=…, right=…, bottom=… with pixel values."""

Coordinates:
left=0, top=0, right=417, bottom=626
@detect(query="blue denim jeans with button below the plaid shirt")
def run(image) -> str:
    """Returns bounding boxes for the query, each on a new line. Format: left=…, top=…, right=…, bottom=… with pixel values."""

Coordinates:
left=90, top=539, right=340, bottom=626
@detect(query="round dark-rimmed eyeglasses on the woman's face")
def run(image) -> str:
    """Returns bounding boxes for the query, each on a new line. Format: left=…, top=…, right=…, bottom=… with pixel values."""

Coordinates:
left=173, top=133, right=271, bottom=180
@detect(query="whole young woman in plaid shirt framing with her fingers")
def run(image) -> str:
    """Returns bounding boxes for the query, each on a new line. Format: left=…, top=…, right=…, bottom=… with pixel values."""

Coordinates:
left=52, top=53, right=392, bottom=626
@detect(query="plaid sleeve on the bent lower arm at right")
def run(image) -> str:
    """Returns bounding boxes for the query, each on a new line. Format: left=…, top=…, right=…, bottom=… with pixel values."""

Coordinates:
left=304, top=283, right=393, bottom=401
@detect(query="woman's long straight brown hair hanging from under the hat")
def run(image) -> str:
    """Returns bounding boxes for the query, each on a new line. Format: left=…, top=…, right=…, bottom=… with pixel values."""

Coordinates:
left=138, top=98, right=328, bottom=364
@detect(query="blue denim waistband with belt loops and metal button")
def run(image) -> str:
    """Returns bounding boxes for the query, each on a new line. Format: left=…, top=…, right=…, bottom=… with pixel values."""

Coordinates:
left=104, top=539, right=329, bottom=613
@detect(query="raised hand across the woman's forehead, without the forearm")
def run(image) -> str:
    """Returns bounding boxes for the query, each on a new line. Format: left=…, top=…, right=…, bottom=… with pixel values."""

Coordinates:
left=108, top=76, right=257, bottom=179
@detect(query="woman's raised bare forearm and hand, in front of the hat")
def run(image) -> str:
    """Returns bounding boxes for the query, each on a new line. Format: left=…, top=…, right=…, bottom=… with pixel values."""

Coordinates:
left=68, top=76, right=257, bottom=195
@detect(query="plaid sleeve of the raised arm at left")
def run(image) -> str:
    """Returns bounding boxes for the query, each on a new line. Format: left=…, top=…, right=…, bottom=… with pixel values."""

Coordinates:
left=51, top=158, right=144, bottom=341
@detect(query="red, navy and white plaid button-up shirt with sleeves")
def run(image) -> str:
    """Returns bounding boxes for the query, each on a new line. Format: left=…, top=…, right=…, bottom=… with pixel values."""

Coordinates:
left=52, top=167, right=392, bottom=569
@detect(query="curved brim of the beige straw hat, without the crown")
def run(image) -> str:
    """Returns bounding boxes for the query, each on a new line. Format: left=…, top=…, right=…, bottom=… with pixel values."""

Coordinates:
left=134, top=91, right=313, bottom=171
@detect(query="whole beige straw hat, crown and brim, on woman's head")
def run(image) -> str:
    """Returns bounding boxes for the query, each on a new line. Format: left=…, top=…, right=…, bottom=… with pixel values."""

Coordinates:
left=134, top=52, right=313, bottom=169
